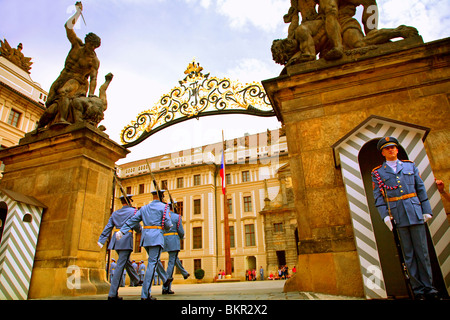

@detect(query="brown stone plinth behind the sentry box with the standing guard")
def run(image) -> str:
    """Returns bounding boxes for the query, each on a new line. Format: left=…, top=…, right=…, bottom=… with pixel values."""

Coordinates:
left=263, top=39, right=450, bottom=296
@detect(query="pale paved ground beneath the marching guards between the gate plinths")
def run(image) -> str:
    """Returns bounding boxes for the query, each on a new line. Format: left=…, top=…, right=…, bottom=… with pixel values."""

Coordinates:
left=37, top=280, right=362, bottom=300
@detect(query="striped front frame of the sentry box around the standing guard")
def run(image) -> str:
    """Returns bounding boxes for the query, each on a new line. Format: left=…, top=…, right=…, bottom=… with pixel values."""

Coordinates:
left=332, top=116, right=450, bottom=299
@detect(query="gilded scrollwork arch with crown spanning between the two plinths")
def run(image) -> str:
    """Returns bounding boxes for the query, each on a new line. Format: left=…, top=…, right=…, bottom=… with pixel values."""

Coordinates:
left=121, top=61, right=275, bottom=147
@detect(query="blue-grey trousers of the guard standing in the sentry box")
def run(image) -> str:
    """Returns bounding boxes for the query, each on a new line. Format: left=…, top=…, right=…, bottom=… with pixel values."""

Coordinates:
left=398, top=224, right=437, bottom=295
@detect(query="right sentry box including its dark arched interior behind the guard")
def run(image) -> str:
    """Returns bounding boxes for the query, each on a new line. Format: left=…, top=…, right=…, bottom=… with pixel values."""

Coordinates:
left=332, top=116, right=450, bottom=299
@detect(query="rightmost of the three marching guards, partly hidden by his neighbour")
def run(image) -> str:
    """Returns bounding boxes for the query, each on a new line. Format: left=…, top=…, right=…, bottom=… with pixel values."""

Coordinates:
left=162, top=203, right=184, bottom=294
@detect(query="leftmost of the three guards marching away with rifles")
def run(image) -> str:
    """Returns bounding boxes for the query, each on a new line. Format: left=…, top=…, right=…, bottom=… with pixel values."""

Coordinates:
left=97, top=195, right=141, bottom=300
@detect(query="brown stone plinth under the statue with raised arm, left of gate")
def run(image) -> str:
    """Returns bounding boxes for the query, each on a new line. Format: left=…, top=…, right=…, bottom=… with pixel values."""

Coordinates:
left=0, top=124, right=129, bottom=298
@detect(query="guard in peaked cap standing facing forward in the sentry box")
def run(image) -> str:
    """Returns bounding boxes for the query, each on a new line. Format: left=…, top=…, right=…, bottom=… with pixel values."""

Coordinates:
left=372, top=137, right=438, bottom=299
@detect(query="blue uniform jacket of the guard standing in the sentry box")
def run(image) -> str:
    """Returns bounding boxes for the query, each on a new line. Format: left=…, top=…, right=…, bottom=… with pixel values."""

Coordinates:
left=372, top=160, right=433, bottom=227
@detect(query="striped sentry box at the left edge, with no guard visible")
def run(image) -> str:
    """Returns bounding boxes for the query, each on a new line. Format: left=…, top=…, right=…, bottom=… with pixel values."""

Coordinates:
left=0, top=189, right=45, bottom=300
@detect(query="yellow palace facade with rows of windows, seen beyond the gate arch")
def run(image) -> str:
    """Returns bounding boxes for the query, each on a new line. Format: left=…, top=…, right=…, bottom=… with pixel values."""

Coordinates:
left=111, top=129, right=297, bottom=282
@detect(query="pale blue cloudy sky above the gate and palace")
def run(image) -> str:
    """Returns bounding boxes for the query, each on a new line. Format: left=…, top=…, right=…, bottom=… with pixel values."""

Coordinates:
left=0, top=0, right=450, bottom=164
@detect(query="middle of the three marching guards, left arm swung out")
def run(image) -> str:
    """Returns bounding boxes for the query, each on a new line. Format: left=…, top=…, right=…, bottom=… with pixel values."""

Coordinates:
left=116, top=191, right=172, bottom=300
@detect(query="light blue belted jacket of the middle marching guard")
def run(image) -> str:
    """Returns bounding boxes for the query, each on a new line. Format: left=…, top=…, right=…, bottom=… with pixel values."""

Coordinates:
left=120, top=200, right=172, bottom=248
